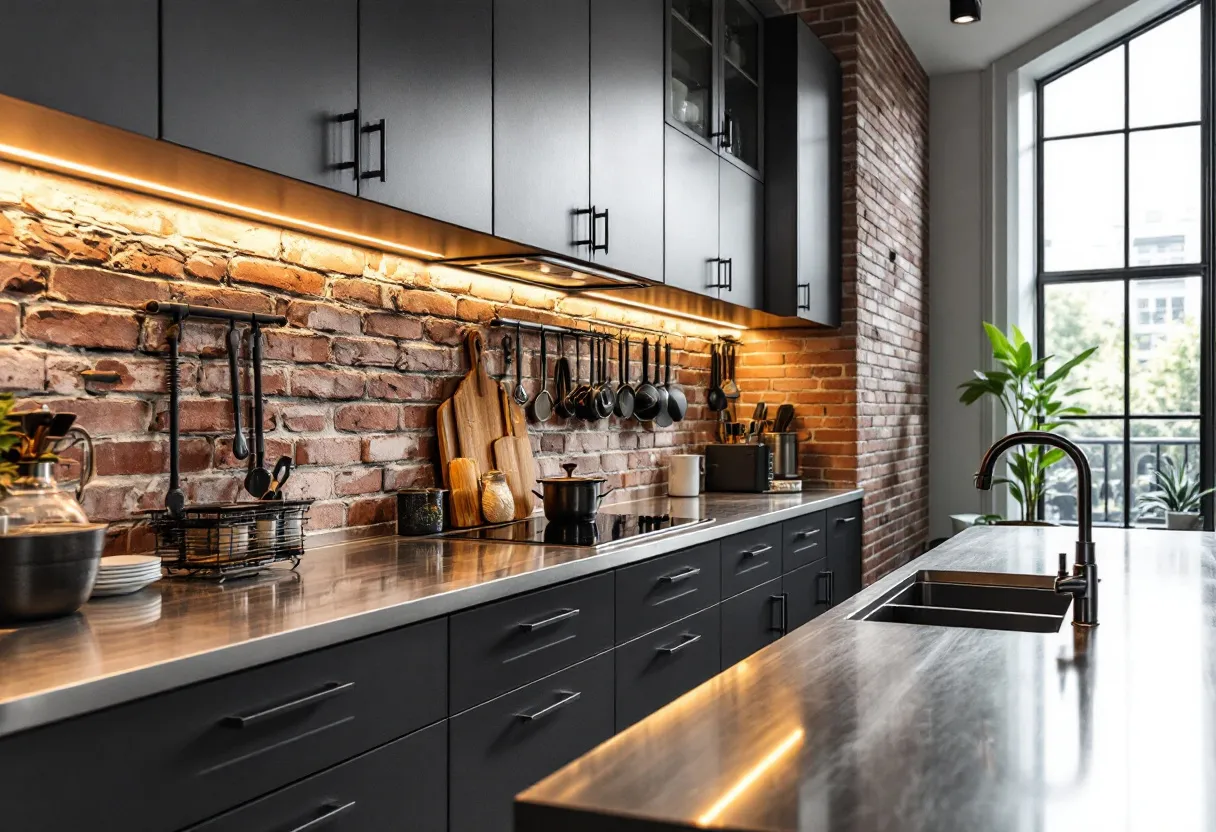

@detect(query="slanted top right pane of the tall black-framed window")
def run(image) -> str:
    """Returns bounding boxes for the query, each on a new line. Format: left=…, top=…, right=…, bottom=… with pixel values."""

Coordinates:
left=1128, top=6, right=1203, bottom=127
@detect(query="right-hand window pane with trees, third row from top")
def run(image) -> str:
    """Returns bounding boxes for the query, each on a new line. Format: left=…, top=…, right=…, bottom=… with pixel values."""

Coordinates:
left=1130, top=277, right=1203, bottom=414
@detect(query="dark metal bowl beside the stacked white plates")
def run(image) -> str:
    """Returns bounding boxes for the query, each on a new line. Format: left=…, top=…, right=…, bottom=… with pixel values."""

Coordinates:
left=0, top=523, right=106, bottom=622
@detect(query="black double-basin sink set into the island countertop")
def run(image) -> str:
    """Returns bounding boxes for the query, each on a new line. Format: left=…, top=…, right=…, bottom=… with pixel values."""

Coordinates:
left=850, top=570, right=1073, bottom=633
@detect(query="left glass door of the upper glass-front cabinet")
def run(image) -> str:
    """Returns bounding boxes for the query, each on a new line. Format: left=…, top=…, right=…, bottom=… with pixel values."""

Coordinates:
left=668, top=0, right=717, bottom=140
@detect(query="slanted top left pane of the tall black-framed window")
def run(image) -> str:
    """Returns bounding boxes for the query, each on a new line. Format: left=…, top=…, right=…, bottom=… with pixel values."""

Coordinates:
left=1043, top=46, right=1124, bottom=136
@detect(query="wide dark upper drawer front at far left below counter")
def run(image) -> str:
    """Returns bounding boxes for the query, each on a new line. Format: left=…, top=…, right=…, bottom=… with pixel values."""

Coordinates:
left=0, top=619, right=447, bottom=832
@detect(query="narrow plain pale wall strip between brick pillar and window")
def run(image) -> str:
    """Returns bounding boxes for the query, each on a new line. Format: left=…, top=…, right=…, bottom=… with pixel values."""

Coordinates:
left=929, top=72, right=986, bottom=538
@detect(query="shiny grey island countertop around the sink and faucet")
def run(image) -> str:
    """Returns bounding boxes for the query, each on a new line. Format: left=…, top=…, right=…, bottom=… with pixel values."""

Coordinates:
left=517, top=528, right=1216, bottom=832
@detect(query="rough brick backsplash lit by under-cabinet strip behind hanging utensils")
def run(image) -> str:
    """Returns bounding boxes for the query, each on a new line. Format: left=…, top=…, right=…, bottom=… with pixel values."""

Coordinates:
left=0, top=164, right=715, bottom=551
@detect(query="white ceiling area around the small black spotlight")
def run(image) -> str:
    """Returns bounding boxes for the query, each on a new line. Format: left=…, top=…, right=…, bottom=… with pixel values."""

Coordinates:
left=883, top=0, right=1097, bottom=75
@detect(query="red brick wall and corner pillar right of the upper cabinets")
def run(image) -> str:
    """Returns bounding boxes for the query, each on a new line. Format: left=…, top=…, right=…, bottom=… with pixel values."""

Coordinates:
left=742, top=0, right=929, bottom=581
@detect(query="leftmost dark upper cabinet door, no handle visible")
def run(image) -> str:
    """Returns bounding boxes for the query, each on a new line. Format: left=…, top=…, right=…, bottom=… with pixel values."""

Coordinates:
left=0, top=0, right=159, bottom=137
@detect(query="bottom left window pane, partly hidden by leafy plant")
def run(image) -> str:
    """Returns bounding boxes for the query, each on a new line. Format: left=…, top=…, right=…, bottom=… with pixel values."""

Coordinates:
left=1043, top=418, right=1124, bottom=525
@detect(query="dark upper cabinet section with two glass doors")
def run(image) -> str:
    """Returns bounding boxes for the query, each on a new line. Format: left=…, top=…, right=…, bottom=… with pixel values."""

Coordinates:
left=668, top=0, right=764, bottom=173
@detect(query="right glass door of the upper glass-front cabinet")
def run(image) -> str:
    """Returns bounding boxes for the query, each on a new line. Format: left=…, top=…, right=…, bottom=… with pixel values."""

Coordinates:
left=720, top=0, right=762, bottom=169
